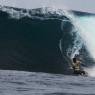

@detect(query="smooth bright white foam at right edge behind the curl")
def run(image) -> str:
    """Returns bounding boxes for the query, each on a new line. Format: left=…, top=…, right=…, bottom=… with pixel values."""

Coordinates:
left=76, top=16, right=95, bottom=60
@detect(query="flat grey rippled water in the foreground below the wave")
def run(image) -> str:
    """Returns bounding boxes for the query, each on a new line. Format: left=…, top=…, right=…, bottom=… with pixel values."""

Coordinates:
left=0, top=70, right=95, bottom=95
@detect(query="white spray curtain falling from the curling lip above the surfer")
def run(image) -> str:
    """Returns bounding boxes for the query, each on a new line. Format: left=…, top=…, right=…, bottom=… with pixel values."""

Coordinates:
left=61, top=11, right=83, bottom=59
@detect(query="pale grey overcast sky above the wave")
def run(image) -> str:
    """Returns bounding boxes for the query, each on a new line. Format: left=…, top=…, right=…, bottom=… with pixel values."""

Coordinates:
left=0, top=0, right=95, bottom=13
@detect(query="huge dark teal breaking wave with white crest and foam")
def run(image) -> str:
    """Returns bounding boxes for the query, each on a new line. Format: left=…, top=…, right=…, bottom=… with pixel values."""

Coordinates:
left=0, top=7, right=95, bottom=74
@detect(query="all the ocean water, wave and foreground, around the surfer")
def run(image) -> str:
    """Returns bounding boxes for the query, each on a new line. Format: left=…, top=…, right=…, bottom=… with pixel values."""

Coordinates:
left=0, top=6, right=95, bottom=95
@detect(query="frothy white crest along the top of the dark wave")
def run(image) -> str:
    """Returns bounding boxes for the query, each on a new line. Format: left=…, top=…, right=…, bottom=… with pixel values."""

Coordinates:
left=0, top=6, right=68, bottom=19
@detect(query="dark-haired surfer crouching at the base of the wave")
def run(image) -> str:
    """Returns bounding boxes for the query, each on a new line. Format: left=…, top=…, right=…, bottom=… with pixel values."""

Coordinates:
left=72, top=58, right=86, bottom=75
